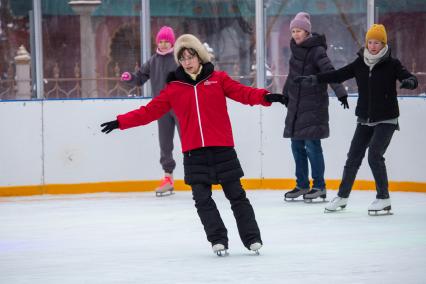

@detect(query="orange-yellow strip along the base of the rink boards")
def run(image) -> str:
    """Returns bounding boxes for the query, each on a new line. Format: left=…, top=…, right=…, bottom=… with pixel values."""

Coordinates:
left=0, top=179, right=426, bottom=197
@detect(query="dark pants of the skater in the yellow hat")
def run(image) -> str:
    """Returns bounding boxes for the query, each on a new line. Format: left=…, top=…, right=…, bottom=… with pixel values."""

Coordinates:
left=337, top=123, right=397, bottom=199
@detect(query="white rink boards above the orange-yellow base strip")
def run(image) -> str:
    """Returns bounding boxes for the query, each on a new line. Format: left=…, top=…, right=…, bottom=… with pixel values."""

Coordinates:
left=0, top=97, right=426, bottom=186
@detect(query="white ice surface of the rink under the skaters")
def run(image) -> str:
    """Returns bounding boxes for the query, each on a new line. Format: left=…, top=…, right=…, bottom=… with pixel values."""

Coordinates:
left=0, top=190, right=426, bottom=284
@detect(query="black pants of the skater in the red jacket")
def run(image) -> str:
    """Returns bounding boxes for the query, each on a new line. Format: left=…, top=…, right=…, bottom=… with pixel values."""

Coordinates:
left=191, top=180, right=262, bottom=248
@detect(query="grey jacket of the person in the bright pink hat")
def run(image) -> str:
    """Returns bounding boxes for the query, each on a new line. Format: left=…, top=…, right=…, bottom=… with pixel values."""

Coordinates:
left=132, top=52, right=178, bottom=98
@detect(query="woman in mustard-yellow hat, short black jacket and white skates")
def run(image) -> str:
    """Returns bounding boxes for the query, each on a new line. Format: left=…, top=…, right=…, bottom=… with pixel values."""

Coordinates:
left=296, top=24, right=417, bottom=214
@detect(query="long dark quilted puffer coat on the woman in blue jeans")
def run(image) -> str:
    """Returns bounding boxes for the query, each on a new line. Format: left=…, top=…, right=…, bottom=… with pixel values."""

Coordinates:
left=283, top=33, right=347, bottom=140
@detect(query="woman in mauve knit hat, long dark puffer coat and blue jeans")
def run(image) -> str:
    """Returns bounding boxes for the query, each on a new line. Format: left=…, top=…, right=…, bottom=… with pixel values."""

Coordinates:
left=283, top=12, right=348, bottom=201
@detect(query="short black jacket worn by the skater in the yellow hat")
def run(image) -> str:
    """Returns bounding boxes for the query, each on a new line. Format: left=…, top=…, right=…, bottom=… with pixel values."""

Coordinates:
left=317, top=47, right=417, bottom=122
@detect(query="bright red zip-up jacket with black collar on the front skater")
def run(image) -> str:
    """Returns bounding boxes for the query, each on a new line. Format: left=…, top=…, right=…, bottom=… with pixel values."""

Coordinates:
left=117, top=63, right=271, bottom=152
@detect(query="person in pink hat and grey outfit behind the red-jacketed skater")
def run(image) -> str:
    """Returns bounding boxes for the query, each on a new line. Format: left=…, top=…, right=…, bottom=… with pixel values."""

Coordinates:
left=121, top=26, right=179, bottom=196
